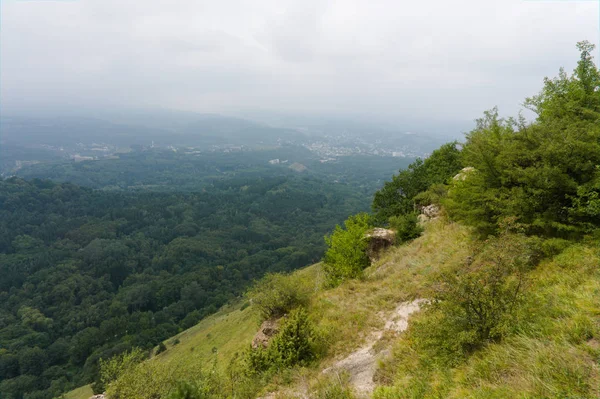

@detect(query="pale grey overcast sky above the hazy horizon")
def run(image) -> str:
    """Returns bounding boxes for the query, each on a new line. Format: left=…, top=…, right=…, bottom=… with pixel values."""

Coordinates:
left=0, top=0, right=600, bottom=125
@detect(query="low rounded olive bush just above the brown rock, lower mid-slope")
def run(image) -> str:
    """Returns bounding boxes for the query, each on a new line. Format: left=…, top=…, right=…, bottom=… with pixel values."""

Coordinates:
left=248, top=273, right=309, bottom=320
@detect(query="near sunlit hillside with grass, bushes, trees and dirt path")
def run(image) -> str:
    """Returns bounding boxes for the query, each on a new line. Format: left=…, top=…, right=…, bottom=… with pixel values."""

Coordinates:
left=77, top=42, right=600, bottom=399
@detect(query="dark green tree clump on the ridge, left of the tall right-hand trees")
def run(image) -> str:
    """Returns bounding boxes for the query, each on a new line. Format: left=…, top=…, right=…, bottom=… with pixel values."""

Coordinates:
left=372, top=142, right=462, bottom=223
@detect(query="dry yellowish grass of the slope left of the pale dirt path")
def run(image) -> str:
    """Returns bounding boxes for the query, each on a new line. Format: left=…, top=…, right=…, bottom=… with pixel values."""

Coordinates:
left=61, top=223, right=468, bottom=399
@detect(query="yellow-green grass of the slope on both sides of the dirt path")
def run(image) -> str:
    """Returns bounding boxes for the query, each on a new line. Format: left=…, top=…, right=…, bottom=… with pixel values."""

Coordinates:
left=64, top=221, right=600, bottom=399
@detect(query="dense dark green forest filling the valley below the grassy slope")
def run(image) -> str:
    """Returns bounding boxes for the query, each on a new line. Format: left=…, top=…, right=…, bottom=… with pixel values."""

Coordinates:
left=0, top=176, right=376, bottom=398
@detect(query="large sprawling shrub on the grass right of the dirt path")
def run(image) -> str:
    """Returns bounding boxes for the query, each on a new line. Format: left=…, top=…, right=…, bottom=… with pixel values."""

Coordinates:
left=411, top=233, right=541, bottom=365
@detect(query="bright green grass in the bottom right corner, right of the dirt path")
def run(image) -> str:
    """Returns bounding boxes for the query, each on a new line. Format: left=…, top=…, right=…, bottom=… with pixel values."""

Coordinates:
left=374, top=233, right=600, bottom=399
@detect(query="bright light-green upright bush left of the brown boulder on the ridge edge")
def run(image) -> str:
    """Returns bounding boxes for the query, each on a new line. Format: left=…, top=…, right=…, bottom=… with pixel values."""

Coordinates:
left=323, top=213, right=372, bottom=286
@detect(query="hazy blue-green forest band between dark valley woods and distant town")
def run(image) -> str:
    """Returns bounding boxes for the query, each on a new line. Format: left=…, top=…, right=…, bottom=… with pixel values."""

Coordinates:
left=11, top=146, right=412, bottom=196
